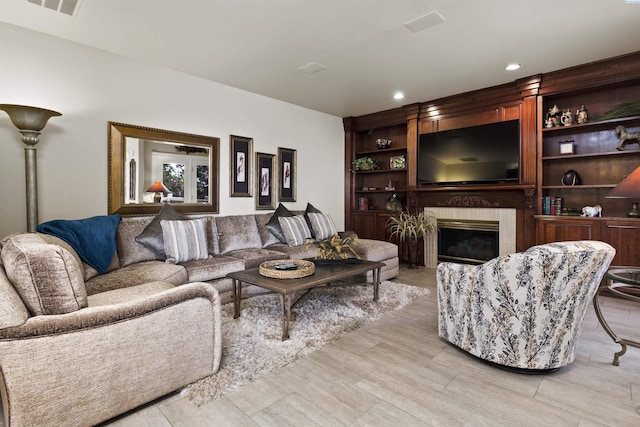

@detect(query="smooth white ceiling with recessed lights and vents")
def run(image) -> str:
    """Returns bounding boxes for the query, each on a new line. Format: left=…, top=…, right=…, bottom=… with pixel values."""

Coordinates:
left=0, top=0, right=640, bottom=117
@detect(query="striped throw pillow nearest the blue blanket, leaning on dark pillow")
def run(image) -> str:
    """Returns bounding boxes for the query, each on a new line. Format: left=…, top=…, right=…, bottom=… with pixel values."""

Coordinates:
left=160, top=219, right=209, bottom=264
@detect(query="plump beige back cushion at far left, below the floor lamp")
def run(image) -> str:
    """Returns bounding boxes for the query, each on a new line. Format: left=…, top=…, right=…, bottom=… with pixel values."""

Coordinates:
left=2, top=233, right=87, bottom=316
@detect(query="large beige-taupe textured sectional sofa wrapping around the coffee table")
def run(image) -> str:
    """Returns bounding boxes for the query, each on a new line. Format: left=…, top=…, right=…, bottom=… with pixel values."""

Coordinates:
left=0, top=209, right=398, bottom=426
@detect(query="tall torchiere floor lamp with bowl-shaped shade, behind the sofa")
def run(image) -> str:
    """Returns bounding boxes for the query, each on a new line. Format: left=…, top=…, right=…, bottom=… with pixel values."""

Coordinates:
left=0, top=104, right=62, bottom=232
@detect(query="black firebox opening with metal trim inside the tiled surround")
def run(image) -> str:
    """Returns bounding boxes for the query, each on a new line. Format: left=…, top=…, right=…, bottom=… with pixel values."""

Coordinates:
left=438, top=218, right=500, bottom=264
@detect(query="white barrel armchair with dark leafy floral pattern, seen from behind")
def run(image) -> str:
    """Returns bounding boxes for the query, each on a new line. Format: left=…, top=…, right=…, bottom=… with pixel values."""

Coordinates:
left=437, top=241, right=615, bottom=370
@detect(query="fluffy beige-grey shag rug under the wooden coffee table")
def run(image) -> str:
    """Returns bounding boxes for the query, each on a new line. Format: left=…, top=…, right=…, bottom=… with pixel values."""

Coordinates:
left=182, top=281, right=429, bottom=406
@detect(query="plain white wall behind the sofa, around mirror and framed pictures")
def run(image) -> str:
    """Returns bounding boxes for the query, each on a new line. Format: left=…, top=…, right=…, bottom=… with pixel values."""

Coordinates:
left=0, top=23, right=344, bottom=238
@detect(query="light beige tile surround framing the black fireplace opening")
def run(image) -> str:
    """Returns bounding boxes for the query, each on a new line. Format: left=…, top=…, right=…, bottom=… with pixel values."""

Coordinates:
left=424, top=207, right=516, bottom=268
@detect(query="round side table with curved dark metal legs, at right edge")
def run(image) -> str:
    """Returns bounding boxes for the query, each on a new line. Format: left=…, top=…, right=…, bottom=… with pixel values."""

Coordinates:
left=593, top=267, right=640, bottom=366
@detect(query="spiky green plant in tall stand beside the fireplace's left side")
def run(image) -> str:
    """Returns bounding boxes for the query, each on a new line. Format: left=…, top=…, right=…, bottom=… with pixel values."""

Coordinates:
left=386, top=211, right=437, bottom=268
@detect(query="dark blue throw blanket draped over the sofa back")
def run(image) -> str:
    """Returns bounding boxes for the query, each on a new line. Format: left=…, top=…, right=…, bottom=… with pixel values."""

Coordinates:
left=36, top=214, right=120, bottom=274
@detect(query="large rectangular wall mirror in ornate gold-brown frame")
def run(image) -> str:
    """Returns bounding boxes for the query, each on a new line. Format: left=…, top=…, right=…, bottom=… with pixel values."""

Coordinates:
left=108, top=122, right=220, bottom=215
